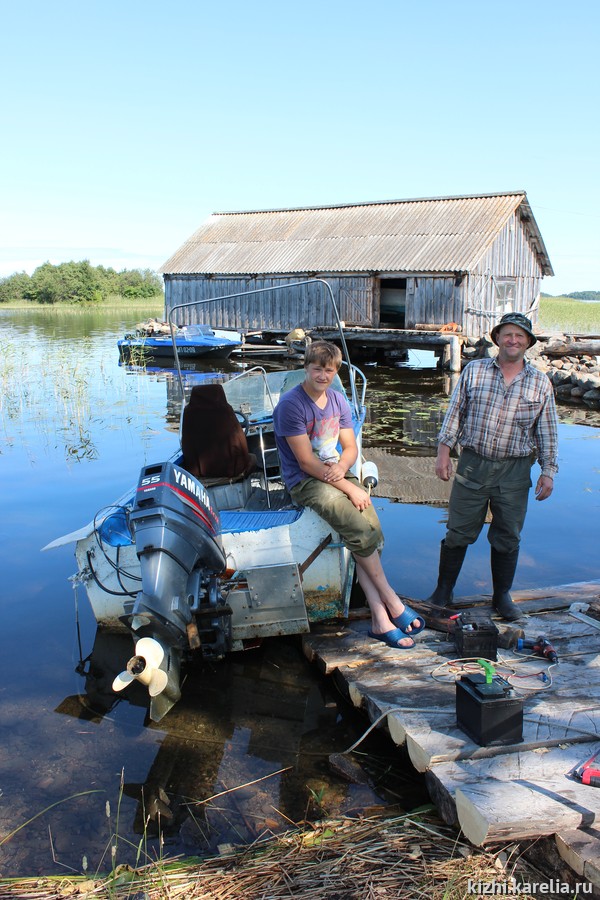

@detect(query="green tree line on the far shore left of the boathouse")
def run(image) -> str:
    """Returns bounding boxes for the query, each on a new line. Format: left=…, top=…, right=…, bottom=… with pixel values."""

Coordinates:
left=0, top=260, right=163, bottom=304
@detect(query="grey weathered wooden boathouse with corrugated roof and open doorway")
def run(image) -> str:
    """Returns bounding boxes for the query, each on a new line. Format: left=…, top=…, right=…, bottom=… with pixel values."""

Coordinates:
left=160, top=191, right=553, bottom=356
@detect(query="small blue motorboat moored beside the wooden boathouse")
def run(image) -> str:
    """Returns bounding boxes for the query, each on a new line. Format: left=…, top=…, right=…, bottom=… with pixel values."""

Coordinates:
left=117, top=320, right=243, bottom=359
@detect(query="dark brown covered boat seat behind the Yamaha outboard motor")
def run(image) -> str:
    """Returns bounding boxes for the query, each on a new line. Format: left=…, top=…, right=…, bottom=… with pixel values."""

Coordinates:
left=181, top=384, right=258, bottom=488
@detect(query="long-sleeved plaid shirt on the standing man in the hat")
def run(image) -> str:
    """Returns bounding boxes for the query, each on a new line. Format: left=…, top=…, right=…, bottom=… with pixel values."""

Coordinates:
left=438, top=359, right=558, bottom=477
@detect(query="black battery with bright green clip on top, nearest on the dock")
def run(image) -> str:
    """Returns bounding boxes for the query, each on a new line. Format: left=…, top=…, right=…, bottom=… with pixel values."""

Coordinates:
left=456, top=673, right=523, bottom=747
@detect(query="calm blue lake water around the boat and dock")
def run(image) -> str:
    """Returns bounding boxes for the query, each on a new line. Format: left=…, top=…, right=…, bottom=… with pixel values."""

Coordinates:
left=0, top=310, right=600, bottom=877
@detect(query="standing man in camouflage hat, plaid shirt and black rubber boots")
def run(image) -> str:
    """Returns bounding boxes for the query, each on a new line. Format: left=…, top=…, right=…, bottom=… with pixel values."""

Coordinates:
left=429, top=313, right=558, bottom=621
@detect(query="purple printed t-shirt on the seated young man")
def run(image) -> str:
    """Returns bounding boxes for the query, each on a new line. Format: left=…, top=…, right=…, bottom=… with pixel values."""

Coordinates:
left=273, top=384, right=352, bottom=490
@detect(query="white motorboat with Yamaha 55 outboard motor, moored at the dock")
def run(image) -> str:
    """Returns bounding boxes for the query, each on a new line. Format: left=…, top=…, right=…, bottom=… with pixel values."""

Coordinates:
left=44, top=279, right=377, bottom=721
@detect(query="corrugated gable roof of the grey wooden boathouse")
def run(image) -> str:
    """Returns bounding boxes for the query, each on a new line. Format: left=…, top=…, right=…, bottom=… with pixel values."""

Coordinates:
left=160, top=191, right=553, bottom=275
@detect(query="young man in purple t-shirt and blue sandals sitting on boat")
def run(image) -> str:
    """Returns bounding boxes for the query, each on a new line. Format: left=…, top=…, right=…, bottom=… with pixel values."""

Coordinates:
left=273, top=341, right=425, bottom=650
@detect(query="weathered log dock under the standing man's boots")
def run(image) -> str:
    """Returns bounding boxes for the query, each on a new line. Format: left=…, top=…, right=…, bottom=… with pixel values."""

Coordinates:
left=303, top=579, right=600, bottom=889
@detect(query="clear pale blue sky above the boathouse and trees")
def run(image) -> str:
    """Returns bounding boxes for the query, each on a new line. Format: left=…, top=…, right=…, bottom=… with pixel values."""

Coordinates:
left=0, top=0, right=600, bottom=294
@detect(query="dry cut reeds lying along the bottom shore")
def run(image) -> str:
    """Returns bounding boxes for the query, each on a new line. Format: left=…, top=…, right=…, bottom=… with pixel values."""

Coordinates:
left=0, top=810, right=547, bottom=900
